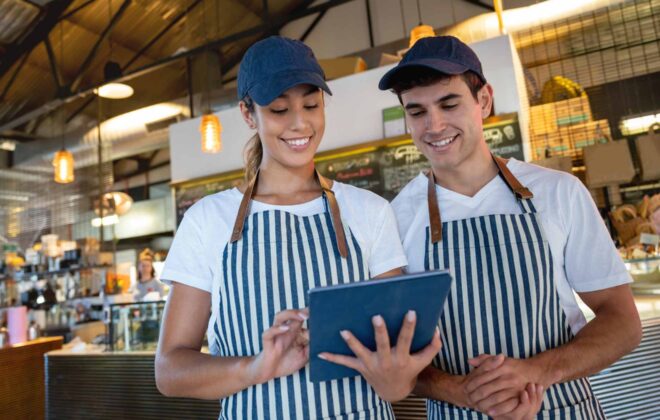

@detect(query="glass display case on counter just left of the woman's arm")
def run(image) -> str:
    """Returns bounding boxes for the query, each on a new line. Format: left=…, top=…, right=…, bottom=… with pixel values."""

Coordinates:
left=106, top=300, right=165, bottom=352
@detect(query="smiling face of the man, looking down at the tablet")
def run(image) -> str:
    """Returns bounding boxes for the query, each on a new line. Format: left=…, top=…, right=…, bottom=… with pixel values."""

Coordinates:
left=400, top=76, right=492, bottom=172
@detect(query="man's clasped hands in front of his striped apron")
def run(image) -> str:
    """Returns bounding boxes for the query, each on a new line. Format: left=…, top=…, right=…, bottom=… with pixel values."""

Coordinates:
left=465, top=355, right=547, bottom=416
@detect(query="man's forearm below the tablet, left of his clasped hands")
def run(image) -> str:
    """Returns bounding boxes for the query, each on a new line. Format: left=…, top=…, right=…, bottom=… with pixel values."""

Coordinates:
left=413, top=366, right=468, bottom=407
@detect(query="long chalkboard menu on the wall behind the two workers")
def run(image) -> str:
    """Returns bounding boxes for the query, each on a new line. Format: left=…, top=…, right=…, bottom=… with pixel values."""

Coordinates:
left=174, top=114, right=524, bottom=226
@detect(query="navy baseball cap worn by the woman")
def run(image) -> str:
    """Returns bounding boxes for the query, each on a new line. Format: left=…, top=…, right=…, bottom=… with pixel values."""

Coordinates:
left=238, top=36, right=332, bottom=106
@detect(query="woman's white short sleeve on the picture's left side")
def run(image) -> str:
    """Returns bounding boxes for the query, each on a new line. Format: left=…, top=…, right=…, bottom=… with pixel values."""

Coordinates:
left=161, top=202, right=213, bottom=293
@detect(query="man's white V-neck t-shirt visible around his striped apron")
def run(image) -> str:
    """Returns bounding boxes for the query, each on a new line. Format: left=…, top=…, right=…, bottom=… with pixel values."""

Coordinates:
left=392, top=159, right=632, bottom=333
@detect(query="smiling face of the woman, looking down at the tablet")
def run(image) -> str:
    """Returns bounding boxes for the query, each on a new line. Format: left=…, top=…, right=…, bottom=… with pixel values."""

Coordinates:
left=241, top=85, right=325, bottom=172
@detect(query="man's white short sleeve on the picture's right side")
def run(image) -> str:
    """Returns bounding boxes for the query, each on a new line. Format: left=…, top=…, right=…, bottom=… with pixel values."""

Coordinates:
left=562, top=181, right=632, bottom=292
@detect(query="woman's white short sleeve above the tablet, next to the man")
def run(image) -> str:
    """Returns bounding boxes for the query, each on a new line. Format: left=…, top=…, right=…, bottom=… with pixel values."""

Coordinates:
left=369, top=202, right=408, bottom=277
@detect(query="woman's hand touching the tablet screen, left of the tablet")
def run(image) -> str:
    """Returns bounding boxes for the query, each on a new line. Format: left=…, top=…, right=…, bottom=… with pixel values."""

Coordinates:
left=248, top=309, right=309, bottom=384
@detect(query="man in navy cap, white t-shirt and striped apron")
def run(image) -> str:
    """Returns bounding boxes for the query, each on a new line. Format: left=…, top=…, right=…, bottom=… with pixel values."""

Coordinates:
left=379, top=36, right=641, bottom=419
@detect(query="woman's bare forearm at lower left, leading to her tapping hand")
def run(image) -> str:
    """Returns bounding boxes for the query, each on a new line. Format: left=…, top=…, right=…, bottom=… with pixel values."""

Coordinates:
left=156, top=348, right=256, bottom=400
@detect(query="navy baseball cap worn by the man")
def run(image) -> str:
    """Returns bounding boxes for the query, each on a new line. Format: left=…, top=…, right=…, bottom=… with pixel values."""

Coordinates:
left=378, top=36, right=486, bottom=90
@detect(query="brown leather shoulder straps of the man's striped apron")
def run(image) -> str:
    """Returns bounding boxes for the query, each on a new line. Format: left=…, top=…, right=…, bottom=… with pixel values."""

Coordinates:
left=426, top=154, right=534, bottom=243
